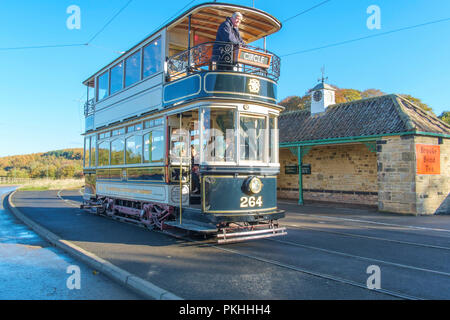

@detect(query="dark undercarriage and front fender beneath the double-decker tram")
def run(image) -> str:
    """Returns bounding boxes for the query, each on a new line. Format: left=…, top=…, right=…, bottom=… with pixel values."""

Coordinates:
left=80, top=198, right=287, bottom=244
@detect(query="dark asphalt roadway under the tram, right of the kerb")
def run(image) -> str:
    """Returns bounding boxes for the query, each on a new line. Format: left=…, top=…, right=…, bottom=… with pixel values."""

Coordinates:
left=6, top=191, right=450, bottom=300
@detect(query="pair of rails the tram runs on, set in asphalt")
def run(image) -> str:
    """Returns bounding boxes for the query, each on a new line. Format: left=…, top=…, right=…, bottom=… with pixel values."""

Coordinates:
left=58, top=190, right=436, bottom=300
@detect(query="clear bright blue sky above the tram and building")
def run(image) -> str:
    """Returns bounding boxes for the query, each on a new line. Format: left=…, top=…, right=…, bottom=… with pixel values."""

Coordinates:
left=0, top=0, right=450, bottom=157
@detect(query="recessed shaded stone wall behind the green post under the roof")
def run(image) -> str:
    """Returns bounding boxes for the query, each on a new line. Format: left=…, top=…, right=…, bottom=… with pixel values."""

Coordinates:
left=278, top=144, right=378, bottom=205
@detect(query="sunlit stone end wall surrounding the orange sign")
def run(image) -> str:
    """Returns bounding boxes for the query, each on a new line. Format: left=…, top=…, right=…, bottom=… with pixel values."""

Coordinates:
left=414, top=136, right=450, bottom=214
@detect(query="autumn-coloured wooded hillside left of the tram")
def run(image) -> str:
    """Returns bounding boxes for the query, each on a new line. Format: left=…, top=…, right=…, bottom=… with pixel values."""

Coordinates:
left=0, top=148, right=83, bottom=179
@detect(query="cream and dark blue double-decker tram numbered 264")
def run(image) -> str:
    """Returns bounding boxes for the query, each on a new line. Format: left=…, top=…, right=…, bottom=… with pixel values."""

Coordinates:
left=82, top=2, right=286, bottom=243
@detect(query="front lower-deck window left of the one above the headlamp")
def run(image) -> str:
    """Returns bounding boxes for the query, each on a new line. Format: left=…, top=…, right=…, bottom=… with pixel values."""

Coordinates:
left=202, top=108, right=236, bottom=162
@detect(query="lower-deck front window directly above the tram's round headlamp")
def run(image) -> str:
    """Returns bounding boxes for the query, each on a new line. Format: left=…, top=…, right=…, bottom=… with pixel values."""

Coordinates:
left=239, top=115, right=266, bottom=162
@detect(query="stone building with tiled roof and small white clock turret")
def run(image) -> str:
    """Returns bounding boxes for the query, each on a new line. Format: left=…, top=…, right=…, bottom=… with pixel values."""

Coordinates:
left=278, top=82, right=450, bottom=215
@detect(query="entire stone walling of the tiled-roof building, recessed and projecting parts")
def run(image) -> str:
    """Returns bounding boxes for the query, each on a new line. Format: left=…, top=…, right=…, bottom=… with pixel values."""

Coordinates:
left=278, top=135, right=450, bottom=215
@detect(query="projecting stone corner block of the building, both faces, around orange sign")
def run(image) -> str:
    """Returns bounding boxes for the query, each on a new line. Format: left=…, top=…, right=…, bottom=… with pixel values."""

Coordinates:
left=377, top=135, right=450, bottom=215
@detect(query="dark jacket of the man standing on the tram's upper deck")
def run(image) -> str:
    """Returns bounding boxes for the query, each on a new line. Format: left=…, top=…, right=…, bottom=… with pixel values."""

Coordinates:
left=212, top=17, right=245, bottom=63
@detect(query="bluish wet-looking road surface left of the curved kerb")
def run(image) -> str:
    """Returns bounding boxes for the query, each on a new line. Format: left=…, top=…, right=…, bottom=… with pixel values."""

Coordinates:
left=0, top=187, right=140, bottom=300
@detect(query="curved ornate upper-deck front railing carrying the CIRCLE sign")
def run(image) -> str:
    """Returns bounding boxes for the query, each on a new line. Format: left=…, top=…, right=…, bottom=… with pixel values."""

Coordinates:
left=166, top=41, right=281, bottom=81
